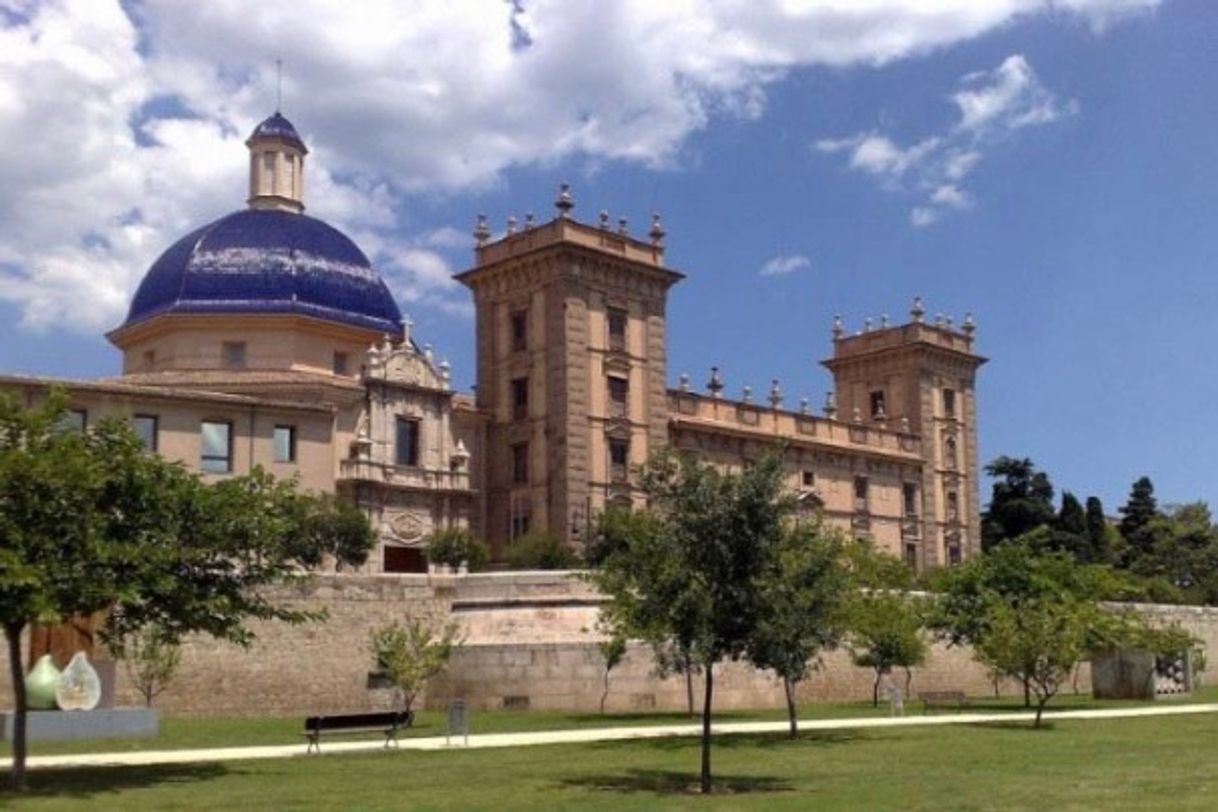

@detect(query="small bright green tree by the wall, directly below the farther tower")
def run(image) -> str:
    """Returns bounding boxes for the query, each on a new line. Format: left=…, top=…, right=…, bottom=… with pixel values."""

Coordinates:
left=849, top=589, right=929, bottom=706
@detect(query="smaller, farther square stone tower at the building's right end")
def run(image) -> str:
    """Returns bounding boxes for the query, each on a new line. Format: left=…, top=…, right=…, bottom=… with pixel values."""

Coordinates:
left=822, top=298, right=985, bottom=569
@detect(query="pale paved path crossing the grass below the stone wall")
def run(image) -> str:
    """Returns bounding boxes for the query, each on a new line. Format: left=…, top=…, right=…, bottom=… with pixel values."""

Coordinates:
left=0, top=704, right=1218, bottom=769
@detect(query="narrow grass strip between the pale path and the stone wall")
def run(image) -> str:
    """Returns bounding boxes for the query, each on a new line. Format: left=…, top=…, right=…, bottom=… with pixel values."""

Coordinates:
left=7, top=687, right=1218, bottom=756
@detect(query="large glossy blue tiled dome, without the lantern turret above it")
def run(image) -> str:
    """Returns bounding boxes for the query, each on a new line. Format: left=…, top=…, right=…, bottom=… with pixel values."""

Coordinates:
left=123, top=208, right=402, bottom=335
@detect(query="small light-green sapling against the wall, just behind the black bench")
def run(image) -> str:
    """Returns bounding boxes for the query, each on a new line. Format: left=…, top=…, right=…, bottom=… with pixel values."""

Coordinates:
left=368, top=617, right=462, bottom=713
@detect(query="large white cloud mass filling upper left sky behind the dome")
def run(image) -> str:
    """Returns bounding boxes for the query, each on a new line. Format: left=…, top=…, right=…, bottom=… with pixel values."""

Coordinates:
left=0, top=0, right=1158, bottom=332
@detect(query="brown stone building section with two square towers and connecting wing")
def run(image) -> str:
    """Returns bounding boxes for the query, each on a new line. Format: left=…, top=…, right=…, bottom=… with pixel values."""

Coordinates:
left=458, top=206, right=984, bottom=569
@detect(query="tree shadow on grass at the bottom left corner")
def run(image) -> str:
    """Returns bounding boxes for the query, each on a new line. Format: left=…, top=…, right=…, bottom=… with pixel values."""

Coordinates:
left=0, top=765, right=234, bottom=808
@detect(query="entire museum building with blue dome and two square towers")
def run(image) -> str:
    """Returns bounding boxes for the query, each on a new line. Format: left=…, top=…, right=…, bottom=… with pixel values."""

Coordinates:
left=0, top=112, right=985, bottom=573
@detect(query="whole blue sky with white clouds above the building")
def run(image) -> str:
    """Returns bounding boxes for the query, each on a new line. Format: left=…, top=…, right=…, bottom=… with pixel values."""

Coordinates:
left=0, top=0, right=1218, bottom=513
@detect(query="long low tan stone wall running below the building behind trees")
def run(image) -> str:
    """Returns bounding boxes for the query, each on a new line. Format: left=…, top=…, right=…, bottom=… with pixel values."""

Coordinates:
left=0, top=572, right=1218, bottom=715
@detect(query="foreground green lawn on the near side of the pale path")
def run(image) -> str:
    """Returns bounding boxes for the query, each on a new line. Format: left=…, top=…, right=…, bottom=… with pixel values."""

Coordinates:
left=0, top=715, right=1218, bottom=812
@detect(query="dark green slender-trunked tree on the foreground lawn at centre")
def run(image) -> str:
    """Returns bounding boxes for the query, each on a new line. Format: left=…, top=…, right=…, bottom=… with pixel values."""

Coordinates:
left=591, top=452, right=792, bottom=793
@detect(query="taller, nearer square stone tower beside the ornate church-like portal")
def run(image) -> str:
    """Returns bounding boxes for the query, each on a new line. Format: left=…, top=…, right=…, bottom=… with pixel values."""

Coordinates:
left=457, top=191, right=682, bottom=558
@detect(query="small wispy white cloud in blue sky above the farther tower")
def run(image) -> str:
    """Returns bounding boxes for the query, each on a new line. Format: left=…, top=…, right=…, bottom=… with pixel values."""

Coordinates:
left=812, top=54, right=1078, bottom=228
